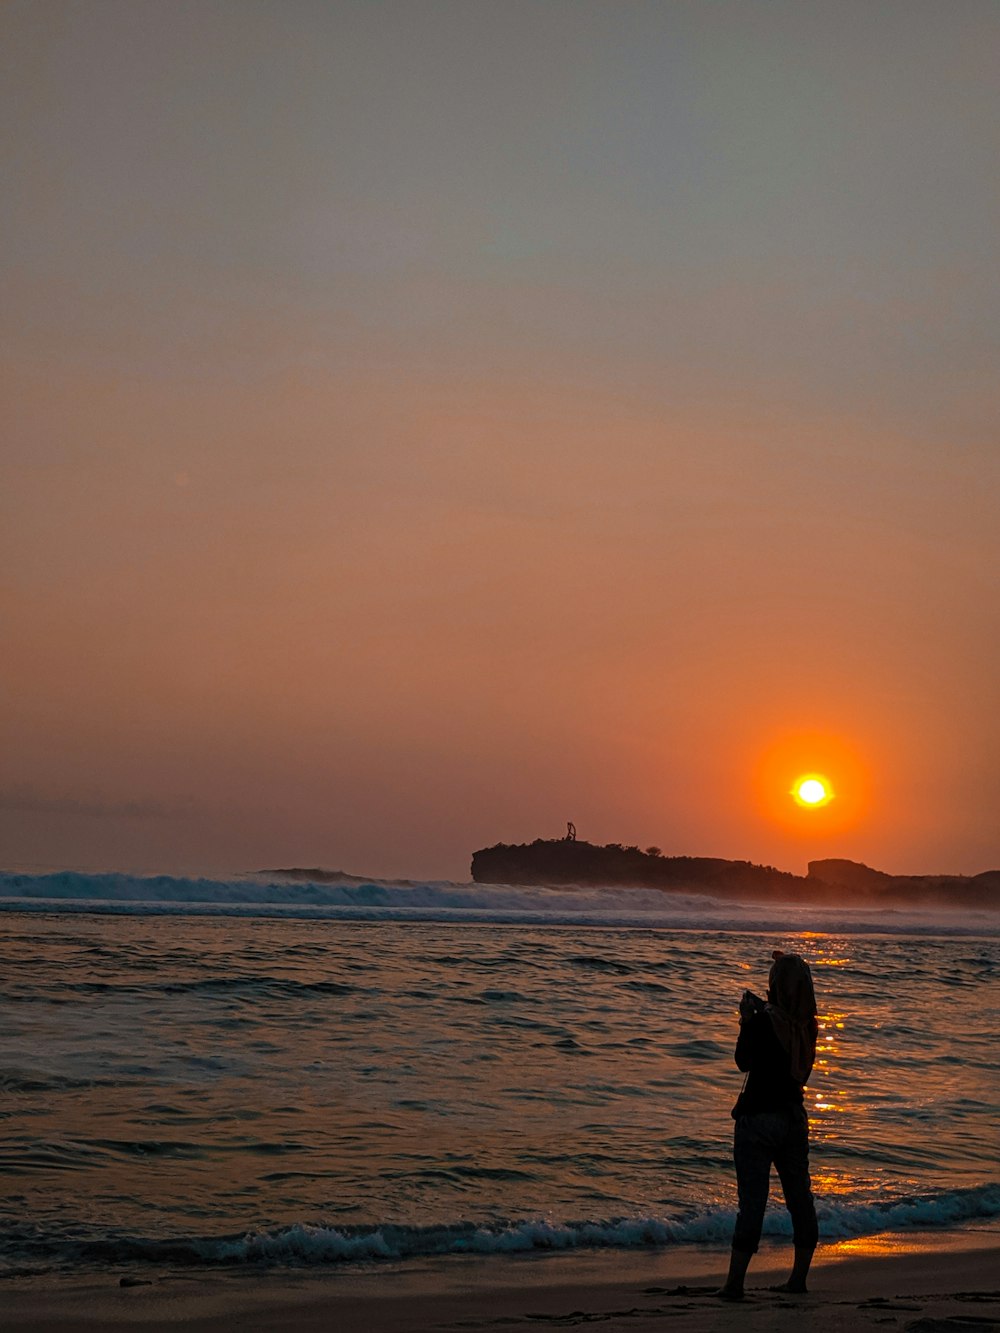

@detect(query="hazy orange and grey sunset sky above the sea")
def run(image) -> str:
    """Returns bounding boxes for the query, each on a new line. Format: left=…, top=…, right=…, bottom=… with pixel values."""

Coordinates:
left=0, top=0, right=1000, bottom=878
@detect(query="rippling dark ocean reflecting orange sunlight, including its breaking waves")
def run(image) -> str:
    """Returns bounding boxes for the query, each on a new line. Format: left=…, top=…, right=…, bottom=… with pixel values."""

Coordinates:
left=0, top=873, right=1000, bottom=1276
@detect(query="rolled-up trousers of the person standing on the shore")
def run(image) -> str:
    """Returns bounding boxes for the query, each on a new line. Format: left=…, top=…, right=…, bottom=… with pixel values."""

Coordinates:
left=732, top=1106, right=819, bottom=1254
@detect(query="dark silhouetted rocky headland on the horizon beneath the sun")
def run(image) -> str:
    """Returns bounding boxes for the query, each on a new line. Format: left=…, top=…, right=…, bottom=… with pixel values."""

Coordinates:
left=472, top=837, right=1000, bottom=910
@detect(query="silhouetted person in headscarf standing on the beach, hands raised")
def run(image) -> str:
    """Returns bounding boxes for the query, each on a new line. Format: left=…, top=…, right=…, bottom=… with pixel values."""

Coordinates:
left=719, top=950, right=819, bottom=1301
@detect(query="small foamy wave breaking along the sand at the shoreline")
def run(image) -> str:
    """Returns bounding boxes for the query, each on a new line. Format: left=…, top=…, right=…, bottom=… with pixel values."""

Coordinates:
left=0, top=1184, right=1000, bottom=1276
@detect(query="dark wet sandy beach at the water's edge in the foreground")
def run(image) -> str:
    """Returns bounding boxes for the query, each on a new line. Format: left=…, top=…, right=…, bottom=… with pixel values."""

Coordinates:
left=3, top=1229, right=1000, bottom=1333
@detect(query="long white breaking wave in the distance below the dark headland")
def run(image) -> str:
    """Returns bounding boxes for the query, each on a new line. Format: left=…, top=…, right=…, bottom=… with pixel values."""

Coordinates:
left=0, top=870, right=1000, bottom=938
